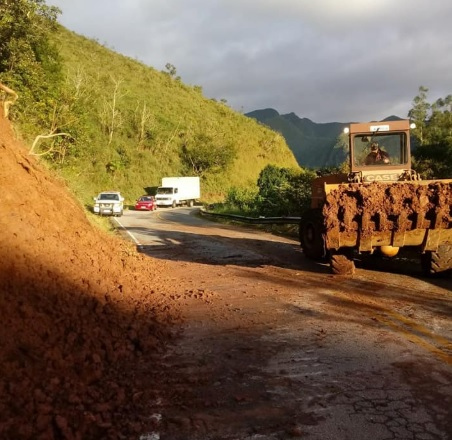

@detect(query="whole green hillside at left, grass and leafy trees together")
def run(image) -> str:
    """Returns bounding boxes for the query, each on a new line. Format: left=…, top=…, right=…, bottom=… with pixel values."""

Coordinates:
left=0, top=0, right=297, bottom=208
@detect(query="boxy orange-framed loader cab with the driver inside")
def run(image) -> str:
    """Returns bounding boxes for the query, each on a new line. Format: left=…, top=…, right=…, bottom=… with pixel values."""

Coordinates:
left=344, top=120, right=411, bottom=182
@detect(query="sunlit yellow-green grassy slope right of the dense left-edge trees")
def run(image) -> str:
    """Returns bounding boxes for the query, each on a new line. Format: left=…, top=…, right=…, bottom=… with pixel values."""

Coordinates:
left=13, top=26, right=298, bottom=203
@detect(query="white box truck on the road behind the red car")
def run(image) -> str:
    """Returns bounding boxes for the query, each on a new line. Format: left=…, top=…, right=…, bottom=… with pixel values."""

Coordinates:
left=155, top=177, right=201, bottom=208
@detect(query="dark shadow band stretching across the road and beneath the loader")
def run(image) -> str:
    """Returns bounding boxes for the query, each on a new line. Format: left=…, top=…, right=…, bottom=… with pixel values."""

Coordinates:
left=118, top=223, right=452, bottom=290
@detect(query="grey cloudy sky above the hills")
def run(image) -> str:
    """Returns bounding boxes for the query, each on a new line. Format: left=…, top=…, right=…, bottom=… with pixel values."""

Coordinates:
left=47, top=0, right=452, bottom=122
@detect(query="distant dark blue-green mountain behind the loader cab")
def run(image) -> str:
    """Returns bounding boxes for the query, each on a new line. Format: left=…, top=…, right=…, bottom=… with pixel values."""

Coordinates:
left=245, top=108, right=401, bottom=168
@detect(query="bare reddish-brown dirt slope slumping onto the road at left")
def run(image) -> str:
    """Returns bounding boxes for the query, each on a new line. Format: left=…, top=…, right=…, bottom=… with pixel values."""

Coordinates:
left=0, top=113, right=178, bottom=440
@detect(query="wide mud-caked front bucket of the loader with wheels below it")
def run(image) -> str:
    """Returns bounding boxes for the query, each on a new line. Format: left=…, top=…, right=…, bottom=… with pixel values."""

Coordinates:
left=323, top=180, right=452, bottom=274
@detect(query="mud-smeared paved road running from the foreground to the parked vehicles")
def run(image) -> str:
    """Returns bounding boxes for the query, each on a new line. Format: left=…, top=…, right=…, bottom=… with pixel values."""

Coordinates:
left=120, top=208, right=452, bottom=440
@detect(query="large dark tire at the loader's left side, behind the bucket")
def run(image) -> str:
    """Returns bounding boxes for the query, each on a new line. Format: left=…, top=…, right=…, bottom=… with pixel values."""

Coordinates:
left=299, top=209, right=326, bottom=260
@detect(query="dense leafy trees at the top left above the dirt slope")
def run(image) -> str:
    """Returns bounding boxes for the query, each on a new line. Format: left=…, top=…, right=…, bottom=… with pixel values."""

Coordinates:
left=0, top=0, right=85, bottom=163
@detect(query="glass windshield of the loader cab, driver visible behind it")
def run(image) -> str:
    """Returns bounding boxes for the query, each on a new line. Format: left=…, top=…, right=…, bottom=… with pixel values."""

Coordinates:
left=352, top=133, right=408, bottom=166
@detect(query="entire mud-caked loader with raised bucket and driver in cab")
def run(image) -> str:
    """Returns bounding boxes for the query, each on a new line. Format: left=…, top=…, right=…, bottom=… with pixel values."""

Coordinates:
left=300, top=120, right=452, bottom=275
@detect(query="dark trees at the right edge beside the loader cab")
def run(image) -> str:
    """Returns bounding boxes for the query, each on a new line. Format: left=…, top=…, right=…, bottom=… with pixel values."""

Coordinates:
left=408, top=87, right=452, bottom=179
